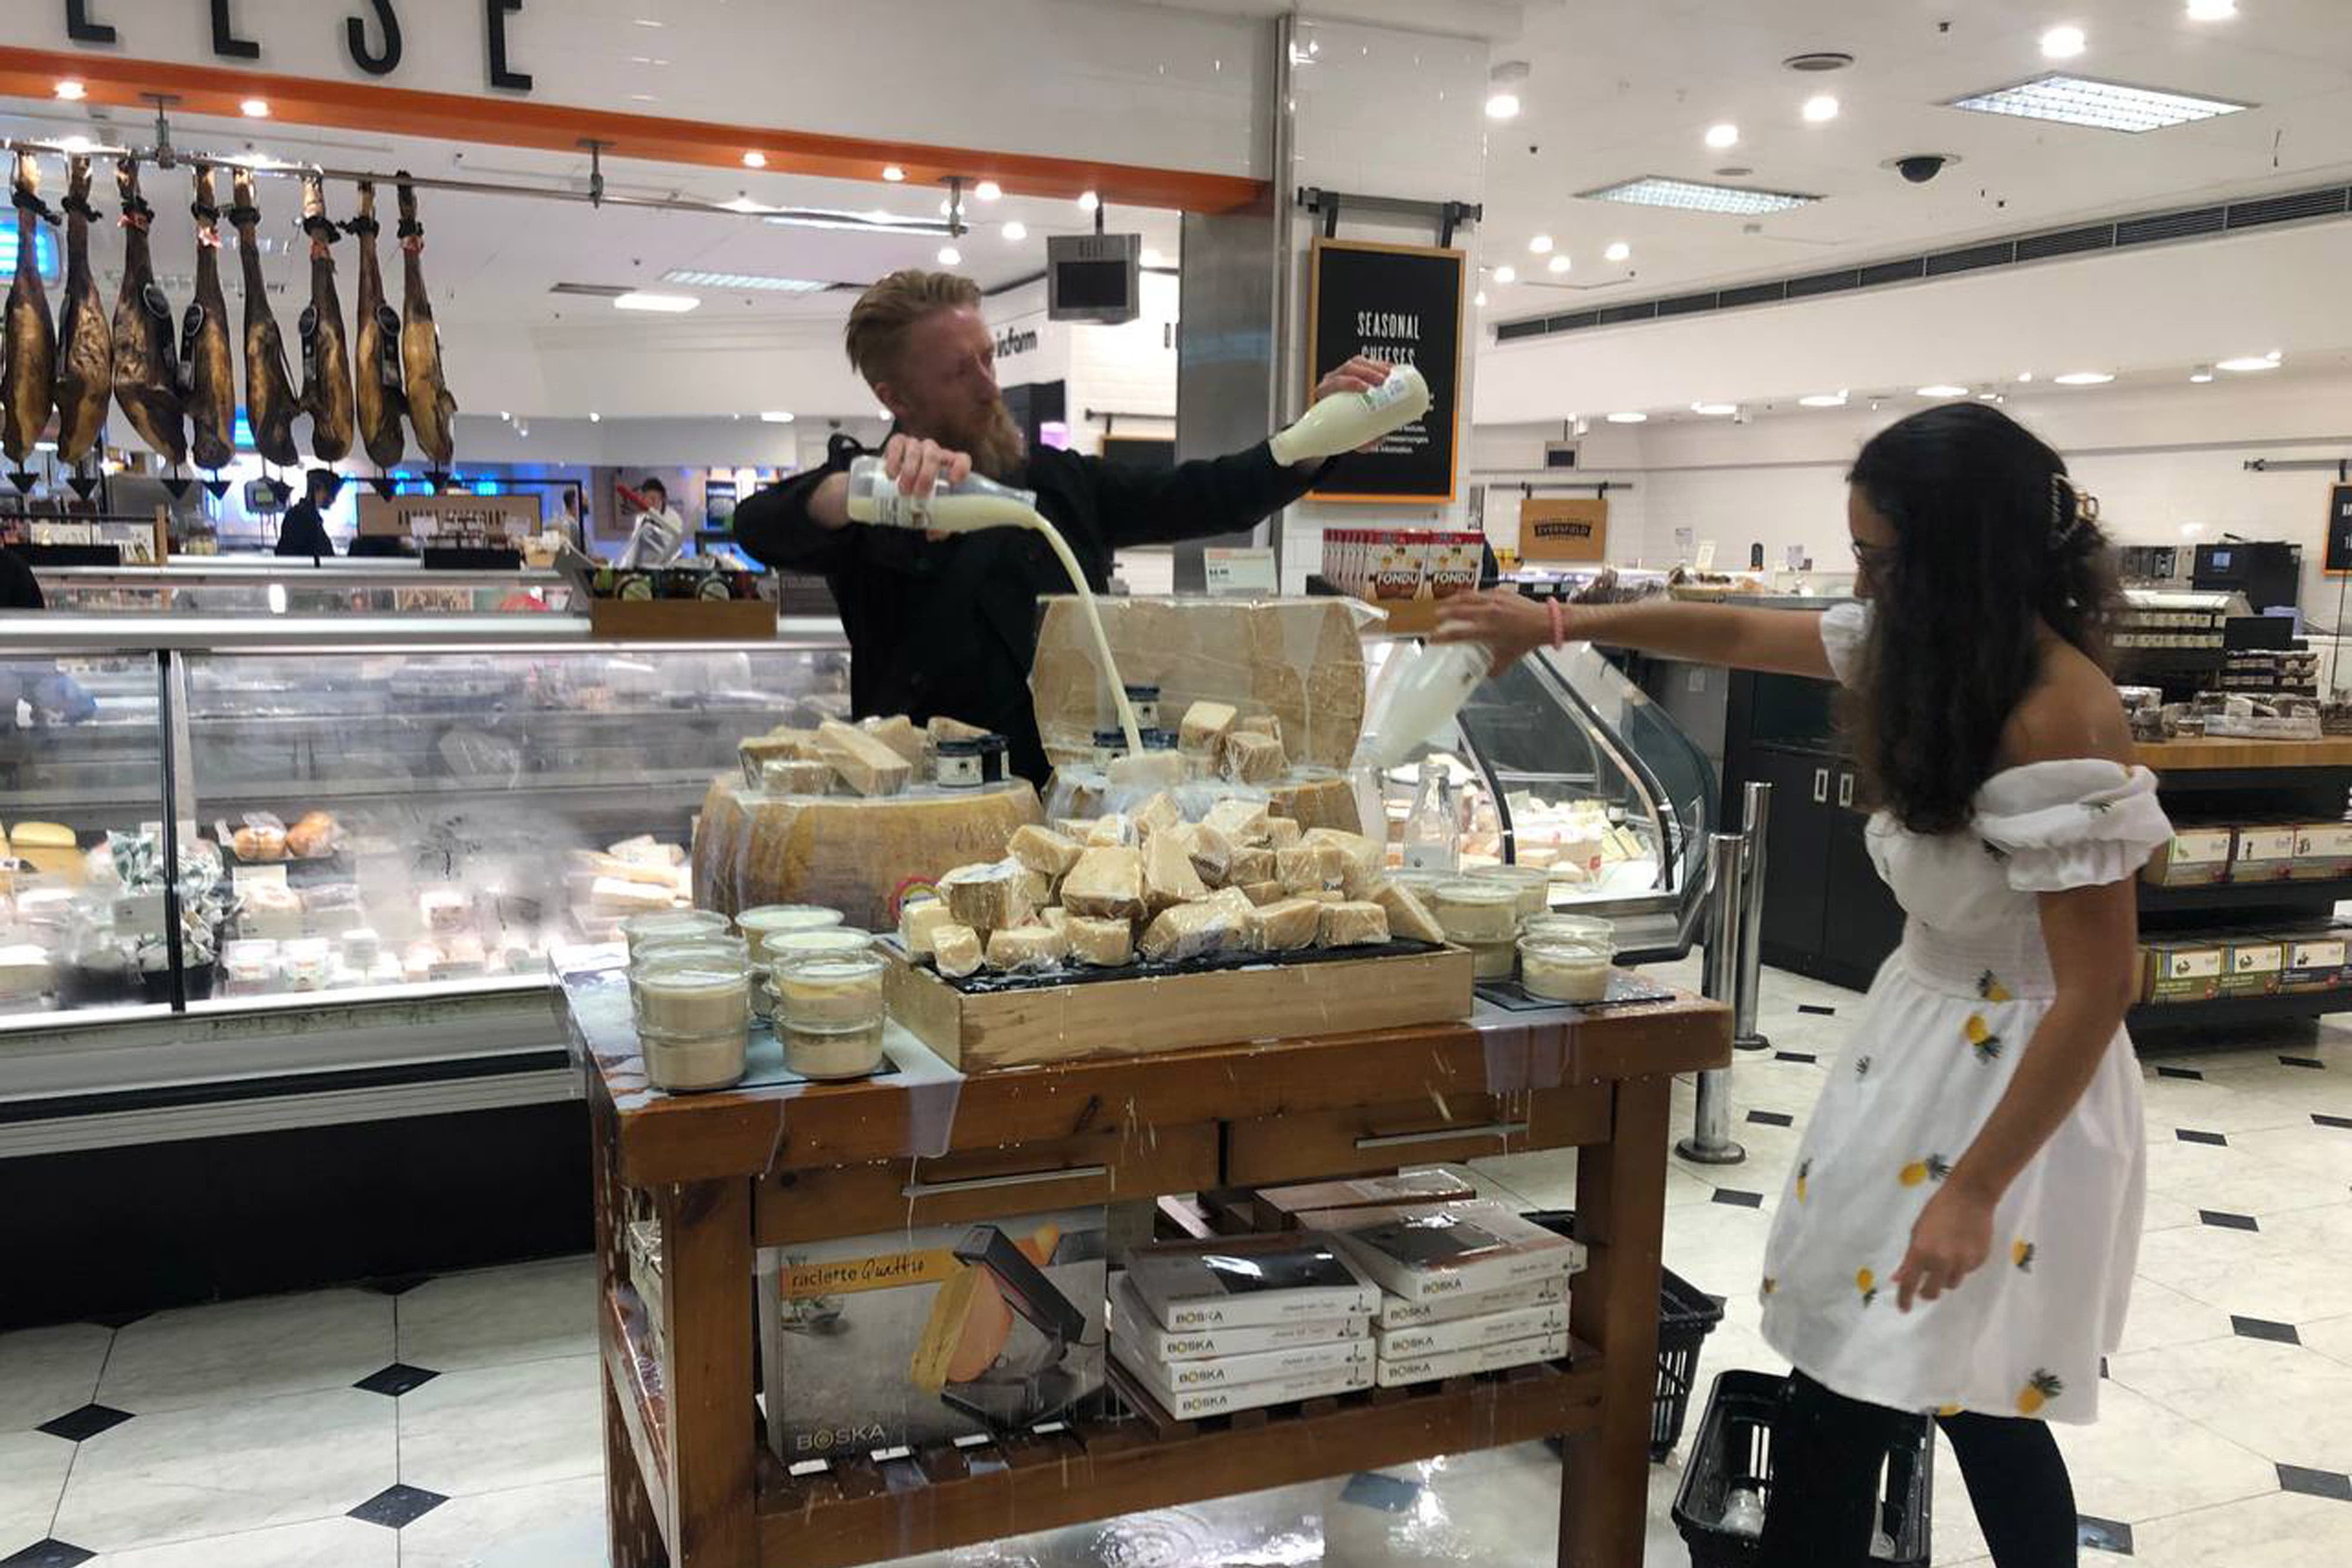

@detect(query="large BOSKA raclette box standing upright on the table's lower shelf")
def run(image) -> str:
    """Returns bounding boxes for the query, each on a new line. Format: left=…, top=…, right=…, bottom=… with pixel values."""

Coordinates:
left=757, top=1208, right=1105, bottom=1465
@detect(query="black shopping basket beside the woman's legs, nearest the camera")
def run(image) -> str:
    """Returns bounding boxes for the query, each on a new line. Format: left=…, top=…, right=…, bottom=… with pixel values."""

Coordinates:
left=1675, top=1370, right=1936, bottom=1568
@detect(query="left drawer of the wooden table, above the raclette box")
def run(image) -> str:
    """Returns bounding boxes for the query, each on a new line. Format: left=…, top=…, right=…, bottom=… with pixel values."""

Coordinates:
left=753, top=1121, right=1218, bottom=1246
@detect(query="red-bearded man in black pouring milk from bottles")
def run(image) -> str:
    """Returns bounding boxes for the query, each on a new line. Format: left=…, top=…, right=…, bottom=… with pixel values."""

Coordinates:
left=734, top=268, right=1388, bottom=785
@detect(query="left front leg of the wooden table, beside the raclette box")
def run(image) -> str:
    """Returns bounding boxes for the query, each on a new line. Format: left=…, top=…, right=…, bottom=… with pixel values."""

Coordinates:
left=654, top=1175, right=760, bottom=1568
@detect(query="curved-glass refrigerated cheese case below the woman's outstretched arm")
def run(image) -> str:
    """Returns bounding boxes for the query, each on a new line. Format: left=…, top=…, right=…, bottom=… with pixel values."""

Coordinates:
left=1364, top=640, right=1719, bottom=964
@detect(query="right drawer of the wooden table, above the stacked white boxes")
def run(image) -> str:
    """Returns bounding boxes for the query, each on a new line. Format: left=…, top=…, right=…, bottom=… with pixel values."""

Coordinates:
left=1225, top=1084, right=1609, bottom=1187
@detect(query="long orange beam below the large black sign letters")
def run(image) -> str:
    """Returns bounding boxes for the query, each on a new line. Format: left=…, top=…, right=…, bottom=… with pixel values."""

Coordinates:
left=0, top=47, right=1268, bottom=212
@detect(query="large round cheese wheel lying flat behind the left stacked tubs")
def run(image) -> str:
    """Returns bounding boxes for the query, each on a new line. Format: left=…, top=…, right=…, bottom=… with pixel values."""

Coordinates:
left=694, top=778, right=1040, bottom=931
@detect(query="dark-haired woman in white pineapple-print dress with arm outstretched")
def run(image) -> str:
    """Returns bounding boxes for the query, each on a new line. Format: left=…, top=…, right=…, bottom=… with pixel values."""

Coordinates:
left=1439, top=404, right=2171, bottom=1568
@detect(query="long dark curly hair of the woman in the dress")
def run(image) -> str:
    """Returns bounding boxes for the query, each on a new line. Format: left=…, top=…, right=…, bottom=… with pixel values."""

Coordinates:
left=1844, top=402, right=2114, bottom=834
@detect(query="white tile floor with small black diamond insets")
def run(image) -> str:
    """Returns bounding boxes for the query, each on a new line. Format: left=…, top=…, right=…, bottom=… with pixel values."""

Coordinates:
left=0, top=973, right=2352, bottom=1568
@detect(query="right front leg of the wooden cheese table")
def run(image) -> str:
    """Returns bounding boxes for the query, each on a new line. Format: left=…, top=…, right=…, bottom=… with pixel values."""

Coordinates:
left=1559, top=1076, right=1672, bottom=1568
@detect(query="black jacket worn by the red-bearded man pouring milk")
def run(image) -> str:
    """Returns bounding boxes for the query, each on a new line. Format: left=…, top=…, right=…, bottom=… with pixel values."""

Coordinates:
left=734, top=435, right=1315, bottom=785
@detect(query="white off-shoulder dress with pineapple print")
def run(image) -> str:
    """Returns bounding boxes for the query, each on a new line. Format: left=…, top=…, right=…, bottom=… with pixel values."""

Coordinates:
left=1762, top=604, right=2171, bottom=1422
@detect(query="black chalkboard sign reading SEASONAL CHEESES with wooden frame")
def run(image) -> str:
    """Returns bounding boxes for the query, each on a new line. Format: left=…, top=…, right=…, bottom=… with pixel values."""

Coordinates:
left=1308, top=240, right=1463, bottom=501
